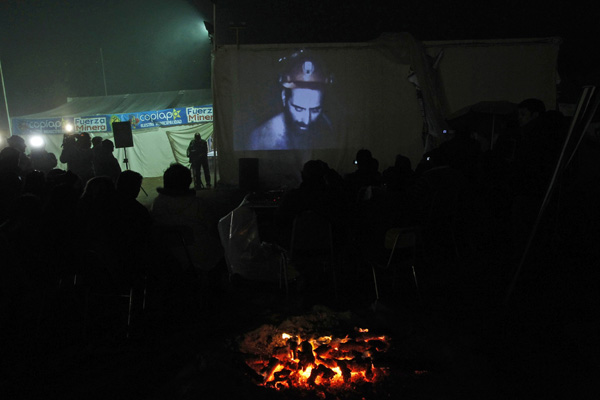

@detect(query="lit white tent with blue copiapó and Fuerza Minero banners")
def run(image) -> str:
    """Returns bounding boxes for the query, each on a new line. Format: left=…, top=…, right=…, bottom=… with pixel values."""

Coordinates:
left=12, top=89, right=213, bottom=177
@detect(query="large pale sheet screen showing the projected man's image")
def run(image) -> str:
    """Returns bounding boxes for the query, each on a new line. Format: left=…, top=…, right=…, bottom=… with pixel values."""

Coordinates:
left=214, top=38, right=423, bottom=188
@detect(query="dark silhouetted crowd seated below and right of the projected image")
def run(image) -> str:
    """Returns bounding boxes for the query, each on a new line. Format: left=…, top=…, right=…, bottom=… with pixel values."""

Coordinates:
left=268, top=99, right=566, bottom=290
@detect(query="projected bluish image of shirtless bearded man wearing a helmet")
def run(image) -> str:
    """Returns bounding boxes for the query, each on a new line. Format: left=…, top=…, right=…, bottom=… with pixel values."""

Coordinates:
left=248, top=51, right=334, bottom=150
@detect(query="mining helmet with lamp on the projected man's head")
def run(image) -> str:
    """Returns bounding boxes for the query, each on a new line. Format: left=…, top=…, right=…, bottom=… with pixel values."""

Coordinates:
left=279, top=50, right=333, bottom=89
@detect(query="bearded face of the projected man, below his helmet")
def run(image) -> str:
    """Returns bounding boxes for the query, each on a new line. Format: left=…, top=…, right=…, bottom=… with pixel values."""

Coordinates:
left=282, top=88, right=323, bottom=134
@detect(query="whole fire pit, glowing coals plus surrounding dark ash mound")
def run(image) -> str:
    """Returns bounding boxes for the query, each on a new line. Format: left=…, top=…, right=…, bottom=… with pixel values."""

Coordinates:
left=239, top=313, right=423, bottom=398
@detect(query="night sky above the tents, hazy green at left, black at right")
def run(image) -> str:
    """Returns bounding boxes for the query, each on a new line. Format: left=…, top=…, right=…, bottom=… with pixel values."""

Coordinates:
left=0, top=0, right=600, bottom=132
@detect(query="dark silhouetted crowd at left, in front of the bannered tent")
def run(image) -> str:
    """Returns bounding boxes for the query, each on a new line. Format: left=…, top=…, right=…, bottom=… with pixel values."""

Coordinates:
left=0, top=136, right=216, bottom=362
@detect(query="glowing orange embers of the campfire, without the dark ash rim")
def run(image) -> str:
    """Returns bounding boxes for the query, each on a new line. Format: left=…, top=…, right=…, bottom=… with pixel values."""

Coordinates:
left=241, top=328, right=390, bottom=395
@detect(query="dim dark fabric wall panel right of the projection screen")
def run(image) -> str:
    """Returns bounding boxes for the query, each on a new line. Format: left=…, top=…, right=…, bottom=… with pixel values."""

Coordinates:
left=424, top=38, right=561, bottom=116
